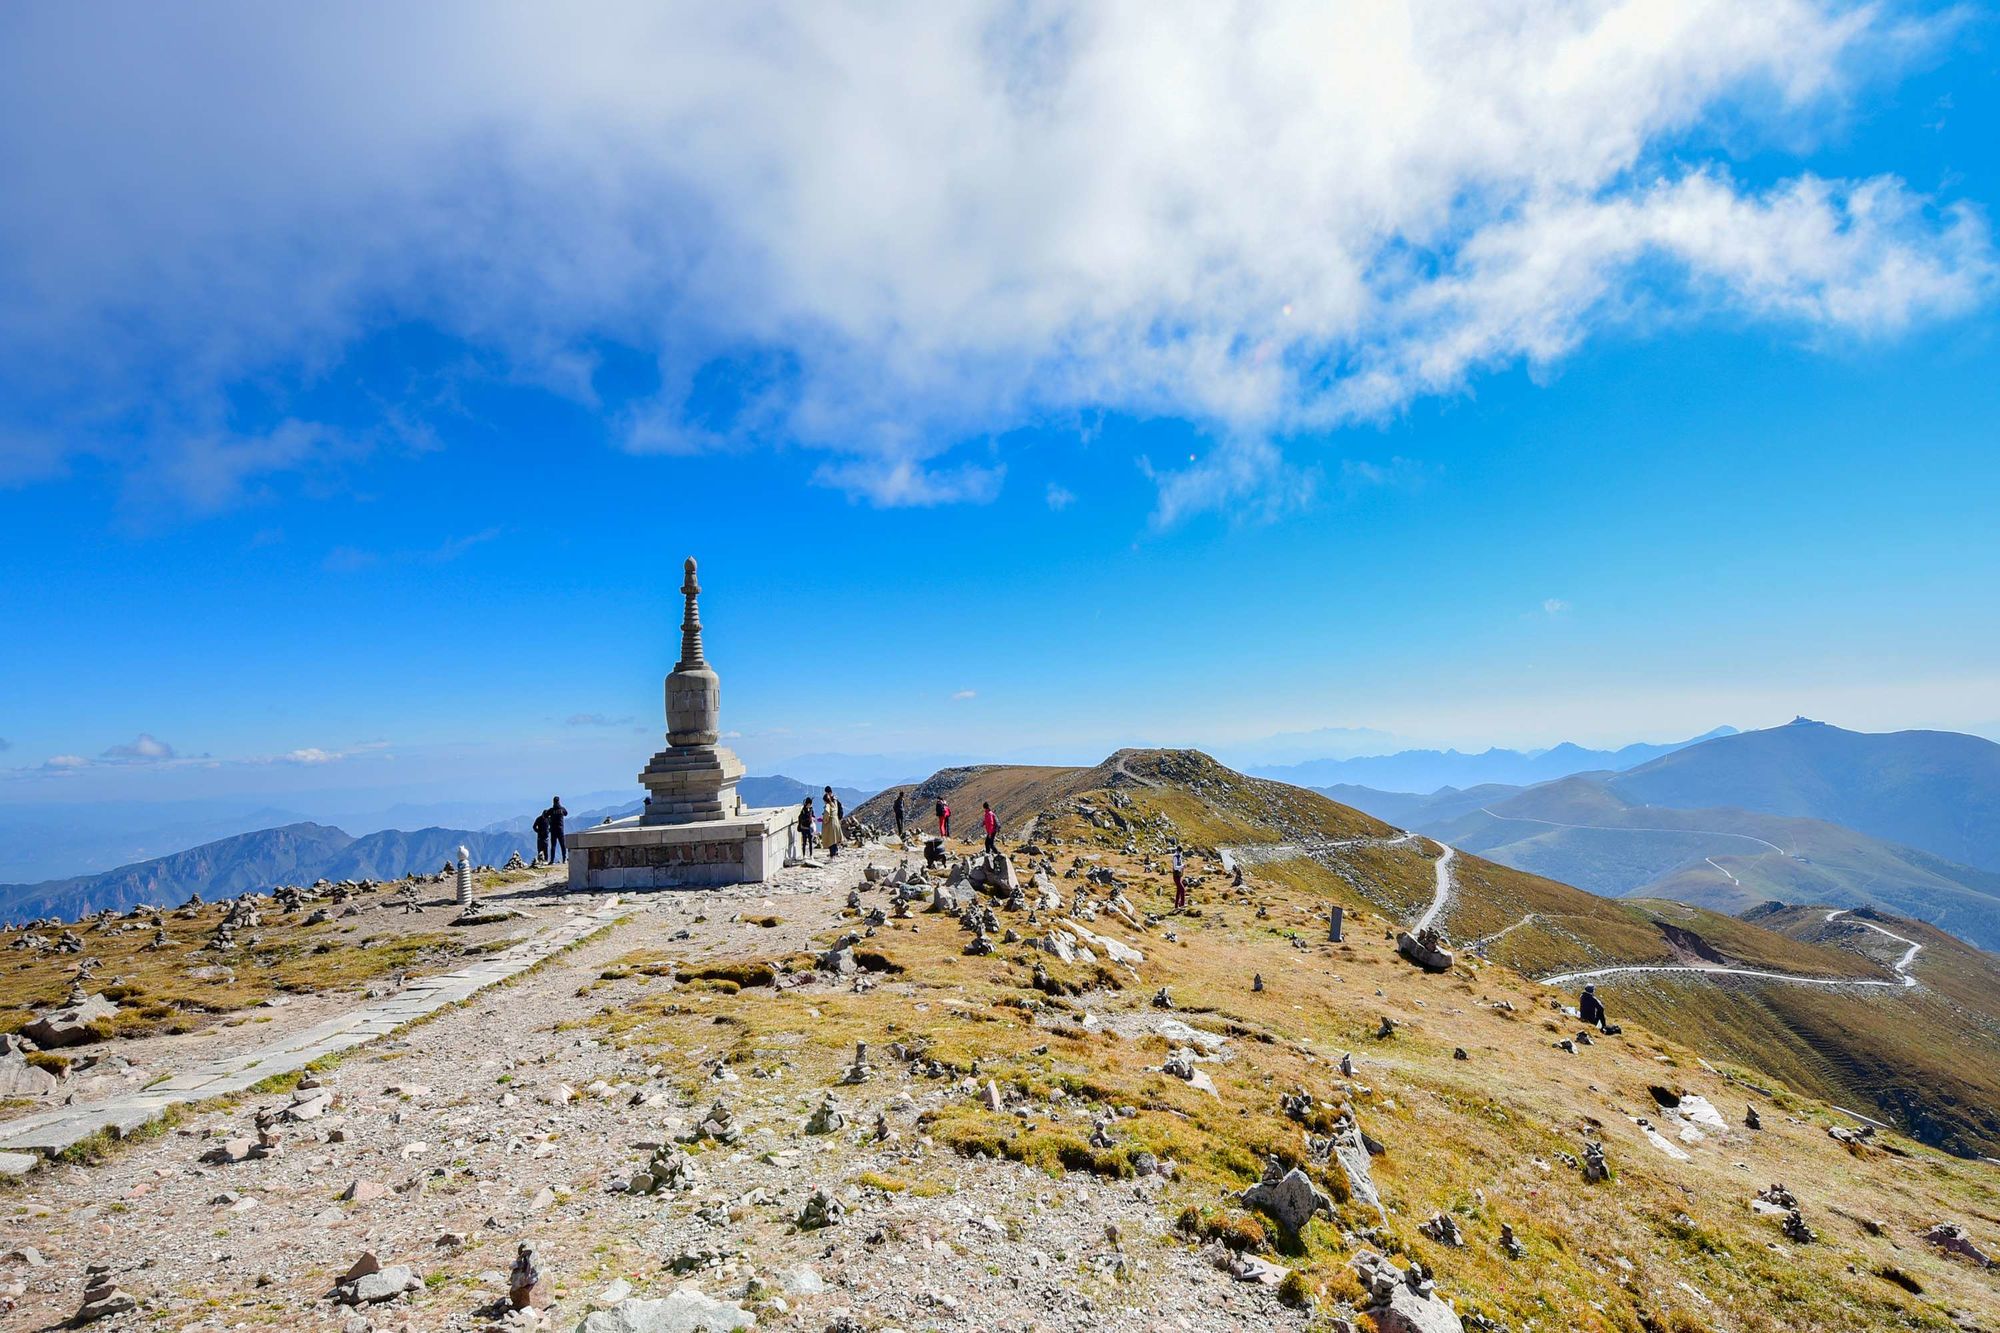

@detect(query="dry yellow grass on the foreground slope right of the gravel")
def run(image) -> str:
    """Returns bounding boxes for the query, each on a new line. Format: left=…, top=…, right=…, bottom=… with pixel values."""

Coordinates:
left=590, top=820, right=2000, bottom=1333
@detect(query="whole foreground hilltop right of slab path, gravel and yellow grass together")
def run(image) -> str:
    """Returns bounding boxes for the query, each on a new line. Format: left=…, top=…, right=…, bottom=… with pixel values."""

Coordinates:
left=0, top=789, right=2000, bottom=1333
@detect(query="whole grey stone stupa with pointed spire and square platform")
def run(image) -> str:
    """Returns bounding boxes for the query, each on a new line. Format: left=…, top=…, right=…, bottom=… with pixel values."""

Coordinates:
left=568, top=556, right=796, bottom=891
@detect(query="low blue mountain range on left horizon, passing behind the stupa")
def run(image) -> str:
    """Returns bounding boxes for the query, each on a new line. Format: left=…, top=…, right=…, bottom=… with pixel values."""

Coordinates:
left=0, top=775, right=870, bottom=921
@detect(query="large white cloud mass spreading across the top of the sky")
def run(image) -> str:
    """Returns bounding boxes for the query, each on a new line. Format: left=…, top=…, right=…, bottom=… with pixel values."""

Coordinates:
left=0, top=0, right=1994, bottom=520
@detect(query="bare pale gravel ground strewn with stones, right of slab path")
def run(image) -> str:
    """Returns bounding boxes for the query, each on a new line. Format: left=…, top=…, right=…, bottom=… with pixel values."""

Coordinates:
left=0, top=853, right=1280, bottom=1329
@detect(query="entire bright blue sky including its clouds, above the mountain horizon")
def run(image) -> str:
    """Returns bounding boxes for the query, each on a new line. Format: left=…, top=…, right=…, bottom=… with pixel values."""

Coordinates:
left=0, top=0, right=2000, bottom=805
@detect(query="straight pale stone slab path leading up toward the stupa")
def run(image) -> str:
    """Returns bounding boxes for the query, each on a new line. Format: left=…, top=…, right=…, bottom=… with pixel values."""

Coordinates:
left=0, top=897, right=644, bottom=1175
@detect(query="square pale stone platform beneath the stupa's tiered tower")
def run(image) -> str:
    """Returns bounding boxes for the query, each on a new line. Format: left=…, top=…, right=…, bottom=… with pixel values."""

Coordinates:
left=568, top=809, right=798, bottom=893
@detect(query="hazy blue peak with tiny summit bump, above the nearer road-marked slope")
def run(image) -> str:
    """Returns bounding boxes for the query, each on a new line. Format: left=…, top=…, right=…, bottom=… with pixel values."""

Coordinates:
left=1604, top=719, right=2000, bottom=871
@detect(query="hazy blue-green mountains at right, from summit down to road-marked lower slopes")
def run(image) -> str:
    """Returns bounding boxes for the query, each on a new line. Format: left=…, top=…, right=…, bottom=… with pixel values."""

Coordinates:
left=1322, top=719, right=2000, bottom=949
